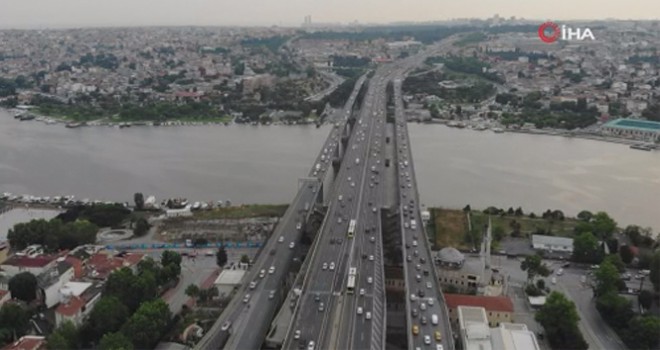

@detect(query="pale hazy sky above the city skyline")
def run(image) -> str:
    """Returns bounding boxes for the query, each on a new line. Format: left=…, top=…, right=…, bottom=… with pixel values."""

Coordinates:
left=0, top=0, right=660, bottom=28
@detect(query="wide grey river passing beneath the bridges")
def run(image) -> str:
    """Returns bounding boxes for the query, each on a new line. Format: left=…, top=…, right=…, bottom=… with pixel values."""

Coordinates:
left=0, top=111, right=660, bottom=229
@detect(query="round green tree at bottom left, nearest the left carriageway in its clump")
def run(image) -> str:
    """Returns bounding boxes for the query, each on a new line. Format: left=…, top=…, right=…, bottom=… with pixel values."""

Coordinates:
left=122, top=299, right=172, bottom=349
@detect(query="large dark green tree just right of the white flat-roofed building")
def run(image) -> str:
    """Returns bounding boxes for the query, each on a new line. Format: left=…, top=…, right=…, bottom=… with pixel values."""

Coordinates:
left=534, top=292, right=588, bottom=349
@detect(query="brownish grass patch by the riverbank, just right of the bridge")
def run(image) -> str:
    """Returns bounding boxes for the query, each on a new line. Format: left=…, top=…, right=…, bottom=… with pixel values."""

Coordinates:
left=431, top=208, right=471, bottom=250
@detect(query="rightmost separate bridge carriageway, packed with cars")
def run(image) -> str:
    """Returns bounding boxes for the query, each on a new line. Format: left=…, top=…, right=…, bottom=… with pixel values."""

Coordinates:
left=393, top=79, right=454, bottom=350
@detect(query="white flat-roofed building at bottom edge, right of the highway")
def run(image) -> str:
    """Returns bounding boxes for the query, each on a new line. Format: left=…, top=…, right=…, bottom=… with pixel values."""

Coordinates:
left=458, top=306, right=540, bottom=350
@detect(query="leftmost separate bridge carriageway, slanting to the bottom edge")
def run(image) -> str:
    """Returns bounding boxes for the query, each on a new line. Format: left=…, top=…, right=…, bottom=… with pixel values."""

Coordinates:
left=197, top=77, right=366, bottom=349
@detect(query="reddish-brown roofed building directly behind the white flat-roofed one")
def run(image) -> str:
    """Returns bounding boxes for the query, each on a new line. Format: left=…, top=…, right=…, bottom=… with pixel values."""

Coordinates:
left=445, top=293, right=513, bottom=327
